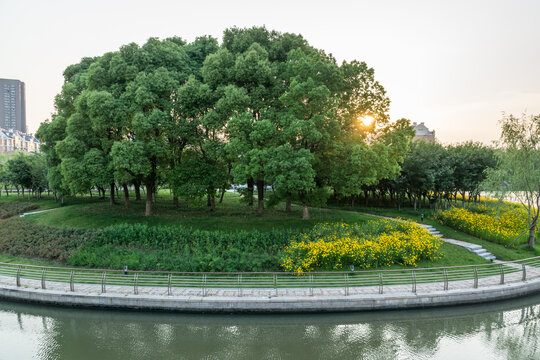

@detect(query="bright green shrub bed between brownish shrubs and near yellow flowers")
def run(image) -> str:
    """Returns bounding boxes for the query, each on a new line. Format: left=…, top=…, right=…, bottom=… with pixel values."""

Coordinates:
left=69, top=224, right=292, bottom=271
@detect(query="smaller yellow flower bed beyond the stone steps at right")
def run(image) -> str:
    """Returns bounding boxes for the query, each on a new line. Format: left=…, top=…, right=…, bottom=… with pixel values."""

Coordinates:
left=435, top=205, right=527, bottom=244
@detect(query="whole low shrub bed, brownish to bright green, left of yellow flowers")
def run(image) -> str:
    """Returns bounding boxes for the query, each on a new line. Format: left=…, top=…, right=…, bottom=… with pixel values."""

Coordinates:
left=0, top=218, right=293, bottom=271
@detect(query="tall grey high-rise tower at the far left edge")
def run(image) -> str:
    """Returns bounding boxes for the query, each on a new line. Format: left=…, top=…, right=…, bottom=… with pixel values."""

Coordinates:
left=0, top=79, right=26, bottom=133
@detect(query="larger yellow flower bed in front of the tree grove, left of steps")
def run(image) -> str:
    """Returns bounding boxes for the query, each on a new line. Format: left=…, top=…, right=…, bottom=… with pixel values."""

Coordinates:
left=281, top=220, right=441, bottom=272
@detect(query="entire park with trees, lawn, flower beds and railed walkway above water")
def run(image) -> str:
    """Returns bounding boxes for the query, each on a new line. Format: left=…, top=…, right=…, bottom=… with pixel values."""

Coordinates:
left=0, top=19, right=540, bottom=360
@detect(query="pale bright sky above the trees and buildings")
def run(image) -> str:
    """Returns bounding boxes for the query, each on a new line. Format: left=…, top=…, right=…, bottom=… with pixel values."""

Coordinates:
left=0, top=0, right=540, bottom=144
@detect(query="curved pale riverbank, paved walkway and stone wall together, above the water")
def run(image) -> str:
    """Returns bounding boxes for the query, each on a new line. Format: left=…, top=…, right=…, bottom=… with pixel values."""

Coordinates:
left=0, top=258, right=540, bottom=313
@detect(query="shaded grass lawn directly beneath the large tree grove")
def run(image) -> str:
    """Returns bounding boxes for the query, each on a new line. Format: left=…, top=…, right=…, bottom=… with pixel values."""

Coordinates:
left=27, top=192, right=373, bottom=231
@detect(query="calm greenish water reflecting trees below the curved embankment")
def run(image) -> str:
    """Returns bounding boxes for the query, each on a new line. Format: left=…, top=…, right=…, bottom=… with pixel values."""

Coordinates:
left=0, top=296, right=540, bottom=360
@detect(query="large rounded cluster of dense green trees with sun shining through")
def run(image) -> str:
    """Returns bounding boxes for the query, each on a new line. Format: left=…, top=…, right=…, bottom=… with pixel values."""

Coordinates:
left=37, top=27, right=413, bottom=218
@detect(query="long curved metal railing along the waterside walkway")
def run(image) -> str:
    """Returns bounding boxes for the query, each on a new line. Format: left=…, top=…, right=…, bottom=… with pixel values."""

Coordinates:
left=0, top=257, right=540, bottom=296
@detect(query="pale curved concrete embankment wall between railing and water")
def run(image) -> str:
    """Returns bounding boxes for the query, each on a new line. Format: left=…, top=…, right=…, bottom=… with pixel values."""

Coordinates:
left=0, top=279, right=540, bottom=313
